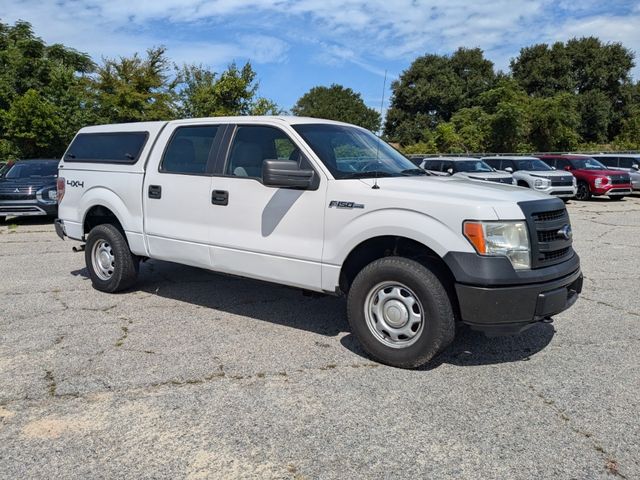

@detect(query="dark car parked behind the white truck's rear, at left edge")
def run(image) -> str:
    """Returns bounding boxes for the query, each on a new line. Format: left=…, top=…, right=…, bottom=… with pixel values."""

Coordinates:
left=0, top=159, right=58, bottom=220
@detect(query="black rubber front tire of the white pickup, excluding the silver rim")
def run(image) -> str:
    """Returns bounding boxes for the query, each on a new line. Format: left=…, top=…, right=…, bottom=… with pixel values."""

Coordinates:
left=347, top=257, right=455, bottom=368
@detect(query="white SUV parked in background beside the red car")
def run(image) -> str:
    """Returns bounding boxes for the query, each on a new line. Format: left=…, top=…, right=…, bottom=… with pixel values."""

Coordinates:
left=482, top=156, right=577, bottom=200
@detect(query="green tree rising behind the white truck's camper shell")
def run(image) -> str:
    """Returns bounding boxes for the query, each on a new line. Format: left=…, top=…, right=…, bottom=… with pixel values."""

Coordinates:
left=93, top=47, right=177, bottom=123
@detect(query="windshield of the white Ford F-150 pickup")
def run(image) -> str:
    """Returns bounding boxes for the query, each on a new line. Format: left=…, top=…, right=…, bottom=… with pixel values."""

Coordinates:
left=293, top=124, right=426, bottom=179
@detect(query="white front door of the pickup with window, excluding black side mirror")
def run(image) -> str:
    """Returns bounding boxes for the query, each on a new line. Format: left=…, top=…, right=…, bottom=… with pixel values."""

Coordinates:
left=210, top=124, right=326, bottom=289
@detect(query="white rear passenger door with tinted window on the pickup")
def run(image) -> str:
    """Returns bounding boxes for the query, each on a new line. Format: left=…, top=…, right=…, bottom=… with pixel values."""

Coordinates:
left=143, top=123, right=226, bottom=268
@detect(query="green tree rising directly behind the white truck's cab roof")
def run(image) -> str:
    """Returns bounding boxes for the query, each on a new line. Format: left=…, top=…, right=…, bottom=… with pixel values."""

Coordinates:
left=178, top=62, right=282, bottom=118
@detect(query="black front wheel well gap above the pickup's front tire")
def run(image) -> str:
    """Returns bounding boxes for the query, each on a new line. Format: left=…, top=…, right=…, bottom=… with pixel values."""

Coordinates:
left=340, top=236, right=455, bottom=295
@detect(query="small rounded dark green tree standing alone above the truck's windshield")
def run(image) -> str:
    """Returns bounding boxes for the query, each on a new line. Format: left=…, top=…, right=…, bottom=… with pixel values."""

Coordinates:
left=291, top=84, right=380, bottom=132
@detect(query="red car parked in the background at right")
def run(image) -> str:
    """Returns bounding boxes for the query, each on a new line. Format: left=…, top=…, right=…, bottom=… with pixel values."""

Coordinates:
left=539, top=155, right=633, bottom=200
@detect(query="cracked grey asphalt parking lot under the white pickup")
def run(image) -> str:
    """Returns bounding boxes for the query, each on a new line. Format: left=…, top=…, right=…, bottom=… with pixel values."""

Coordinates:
left=0, top=196, right=640, bottom=479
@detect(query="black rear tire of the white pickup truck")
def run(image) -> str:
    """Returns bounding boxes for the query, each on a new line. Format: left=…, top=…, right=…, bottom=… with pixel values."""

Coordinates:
left=84, top=223, right=140, bottom=293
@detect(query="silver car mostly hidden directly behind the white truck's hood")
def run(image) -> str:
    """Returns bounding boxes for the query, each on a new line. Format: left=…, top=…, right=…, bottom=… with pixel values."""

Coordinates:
left=420, top=157, right=516, bottom=185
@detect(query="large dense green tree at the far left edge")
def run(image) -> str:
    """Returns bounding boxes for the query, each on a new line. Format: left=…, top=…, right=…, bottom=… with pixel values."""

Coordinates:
left=0, top=21, right=95, bottom=158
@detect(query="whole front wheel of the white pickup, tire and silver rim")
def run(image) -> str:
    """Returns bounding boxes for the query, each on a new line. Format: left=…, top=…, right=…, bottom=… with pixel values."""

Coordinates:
left=347, top=257, right=455, bottom=368
